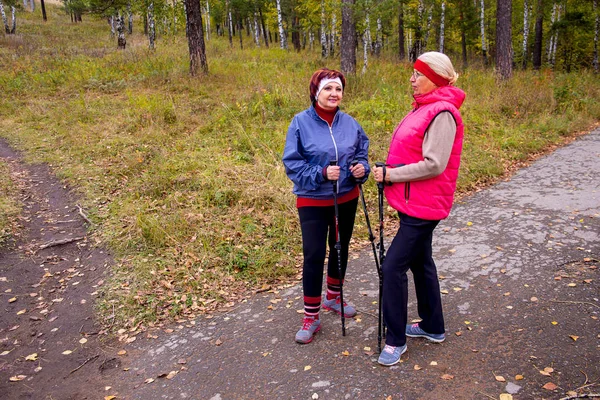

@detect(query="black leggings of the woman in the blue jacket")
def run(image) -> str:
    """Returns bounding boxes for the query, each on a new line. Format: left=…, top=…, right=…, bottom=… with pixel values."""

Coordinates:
left=298, top=198, right=358, bottom=297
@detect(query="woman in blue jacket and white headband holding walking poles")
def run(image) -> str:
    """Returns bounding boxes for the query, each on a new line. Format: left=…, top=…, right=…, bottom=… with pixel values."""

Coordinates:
left=283, top=68, right=370, bottom=343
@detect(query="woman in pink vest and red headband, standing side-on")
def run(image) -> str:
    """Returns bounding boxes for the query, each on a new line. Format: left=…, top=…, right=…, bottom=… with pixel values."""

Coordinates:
left=373, top=52, right=465, bottom=366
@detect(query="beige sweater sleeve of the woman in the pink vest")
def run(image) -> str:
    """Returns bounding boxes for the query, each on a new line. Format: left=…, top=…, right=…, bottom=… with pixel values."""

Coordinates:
left=387, top=111, right=456, bottom=182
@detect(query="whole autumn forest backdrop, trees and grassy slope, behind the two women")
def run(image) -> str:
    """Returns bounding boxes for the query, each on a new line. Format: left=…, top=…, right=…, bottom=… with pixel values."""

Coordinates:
left=0, top=0, right=600, bottom=330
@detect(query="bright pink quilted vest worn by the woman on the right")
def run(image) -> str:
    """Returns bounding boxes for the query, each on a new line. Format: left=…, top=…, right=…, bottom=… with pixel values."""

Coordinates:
left=385, top=86, right=465, bottom=221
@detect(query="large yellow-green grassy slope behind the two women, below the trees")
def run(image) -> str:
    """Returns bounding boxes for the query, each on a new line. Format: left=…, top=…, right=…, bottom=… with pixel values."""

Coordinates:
left=0, top=7, right=600, bottom=326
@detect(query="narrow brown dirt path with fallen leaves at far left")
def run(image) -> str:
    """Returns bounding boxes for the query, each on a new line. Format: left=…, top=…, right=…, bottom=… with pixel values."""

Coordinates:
left=0, top=140, right=120, bottom=399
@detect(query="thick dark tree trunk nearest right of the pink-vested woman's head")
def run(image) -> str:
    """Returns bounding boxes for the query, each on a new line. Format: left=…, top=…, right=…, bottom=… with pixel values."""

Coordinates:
left=496, top=0, right=512, bottom=80
